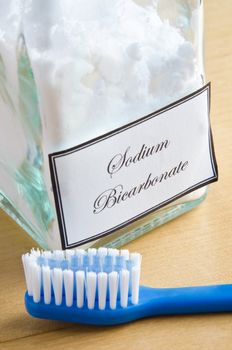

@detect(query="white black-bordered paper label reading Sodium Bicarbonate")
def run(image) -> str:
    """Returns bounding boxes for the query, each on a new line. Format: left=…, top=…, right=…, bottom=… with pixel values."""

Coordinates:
left=49, top=84, right=217, bottom=248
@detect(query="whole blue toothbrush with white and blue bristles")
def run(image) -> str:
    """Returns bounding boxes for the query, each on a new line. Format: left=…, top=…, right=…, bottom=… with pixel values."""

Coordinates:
left=22, top=247, right=232, bottom=325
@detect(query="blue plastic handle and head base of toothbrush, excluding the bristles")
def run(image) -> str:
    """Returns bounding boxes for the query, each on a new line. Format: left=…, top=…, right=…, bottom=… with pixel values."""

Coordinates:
left=25, top=284, right=232, bottom=326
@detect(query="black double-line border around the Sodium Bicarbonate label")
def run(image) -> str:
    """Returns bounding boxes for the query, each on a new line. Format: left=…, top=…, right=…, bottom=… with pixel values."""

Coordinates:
left=48, top=82, right=218, bottom=249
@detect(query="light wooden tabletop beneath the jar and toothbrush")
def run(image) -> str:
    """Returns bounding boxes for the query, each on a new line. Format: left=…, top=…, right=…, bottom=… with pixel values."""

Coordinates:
left=0, top=0, right=232, bottom=350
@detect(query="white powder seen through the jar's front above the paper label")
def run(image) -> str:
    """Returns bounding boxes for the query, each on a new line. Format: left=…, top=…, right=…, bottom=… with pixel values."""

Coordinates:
left=24, top=0, right=202, bottom=151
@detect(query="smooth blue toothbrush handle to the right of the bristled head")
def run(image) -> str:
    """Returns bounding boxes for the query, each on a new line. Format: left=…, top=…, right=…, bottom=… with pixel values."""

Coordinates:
left=138, top=284, right=232, bottom=317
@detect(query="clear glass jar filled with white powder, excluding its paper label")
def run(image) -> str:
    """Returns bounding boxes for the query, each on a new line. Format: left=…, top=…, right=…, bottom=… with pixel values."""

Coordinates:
left=0, top=0, right=206, bottom=249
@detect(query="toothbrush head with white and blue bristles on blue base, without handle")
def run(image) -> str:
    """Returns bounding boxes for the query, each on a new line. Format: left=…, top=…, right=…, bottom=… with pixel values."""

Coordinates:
left=22, top=247, right=142, bottom=325
